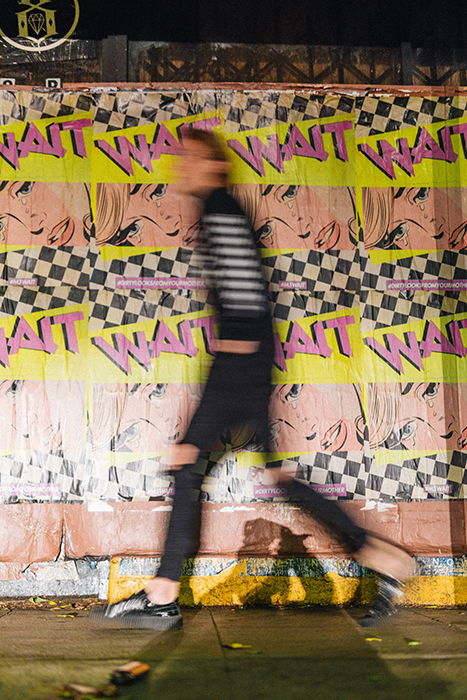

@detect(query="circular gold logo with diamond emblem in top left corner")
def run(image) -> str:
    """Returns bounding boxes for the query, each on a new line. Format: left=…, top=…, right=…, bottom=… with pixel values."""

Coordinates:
left=0, top=0, right=79, bottom=51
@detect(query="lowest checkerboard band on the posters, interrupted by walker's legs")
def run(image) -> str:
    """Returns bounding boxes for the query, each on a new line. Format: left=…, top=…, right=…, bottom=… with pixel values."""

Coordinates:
left=0, top=452, right=467, bottom=503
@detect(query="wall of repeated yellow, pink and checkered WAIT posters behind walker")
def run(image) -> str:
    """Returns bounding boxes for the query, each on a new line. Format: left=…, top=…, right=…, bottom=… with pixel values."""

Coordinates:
left=0, top=88, right=467, bottom=503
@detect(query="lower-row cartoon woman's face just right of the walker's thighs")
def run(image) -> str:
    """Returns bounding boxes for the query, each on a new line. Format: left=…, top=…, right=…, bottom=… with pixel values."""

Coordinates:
left=270, top=384, right=364, bottom=452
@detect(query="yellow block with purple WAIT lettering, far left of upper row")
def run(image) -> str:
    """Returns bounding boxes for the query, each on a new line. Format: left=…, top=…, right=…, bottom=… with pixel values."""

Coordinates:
left=0, top=112, right=92, bottom=183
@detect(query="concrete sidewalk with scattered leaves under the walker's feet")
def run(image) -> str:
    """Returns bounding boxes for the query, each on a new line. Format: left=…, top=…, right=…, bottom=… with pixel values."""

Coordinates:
left=0, top=604, right=467, bottom=700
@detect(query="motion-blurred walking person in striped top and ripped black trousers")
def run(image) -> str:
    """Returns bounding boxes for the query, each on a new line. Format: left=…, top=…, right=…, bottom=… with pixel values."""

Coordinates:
left=99, top=129, right=411, bottom=630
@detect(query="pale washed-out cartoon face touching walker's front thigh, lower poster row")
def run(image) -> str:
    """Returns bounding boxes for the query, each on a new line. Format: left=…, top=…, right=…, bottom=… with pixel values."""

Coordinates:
left=92, top=384, right=201, bottom=452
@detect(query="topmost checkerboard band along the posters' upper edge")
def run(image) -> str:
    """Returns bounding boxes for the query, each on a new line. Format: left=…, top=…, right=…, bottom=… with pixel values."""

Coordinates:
left=0, top=88, right=467, bottom=138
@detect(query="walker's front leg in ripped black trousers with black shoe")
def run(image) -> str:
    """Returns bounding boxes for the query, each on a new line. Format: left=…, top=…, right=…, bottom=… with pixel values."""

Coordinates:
left=98, top=353, right=274, bottom=629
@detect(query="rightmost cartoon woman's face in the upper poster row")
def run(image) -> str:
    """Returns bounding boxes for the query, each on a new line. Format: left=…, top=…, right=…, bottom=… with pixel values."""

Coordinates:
left=362, top=187, right=467, bottom=250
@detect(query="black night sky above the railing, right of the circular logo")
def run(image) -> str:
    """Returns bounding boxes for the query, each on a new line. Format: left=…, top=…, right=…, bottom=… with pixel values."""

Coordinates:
left=75, top=0, right=467, bottom=49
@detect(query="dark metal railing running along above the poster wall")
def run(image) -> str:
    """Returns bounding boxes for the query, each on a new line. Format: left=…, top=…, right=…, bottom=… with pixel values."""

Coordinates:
left=0, top=35, right=467, bottom=87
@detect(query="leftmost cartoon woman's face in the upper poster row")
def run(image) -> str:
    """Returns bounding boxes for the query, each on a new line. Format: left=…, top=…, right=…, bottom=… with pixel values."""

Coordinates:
left=0, top=181, right=91, bottom=246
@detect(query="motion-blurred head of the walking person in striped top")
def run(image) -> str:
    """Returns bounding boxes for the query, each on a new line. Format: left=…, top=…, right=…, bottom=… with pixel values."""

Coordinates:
left=179, top=129, right=230, bottom=197
